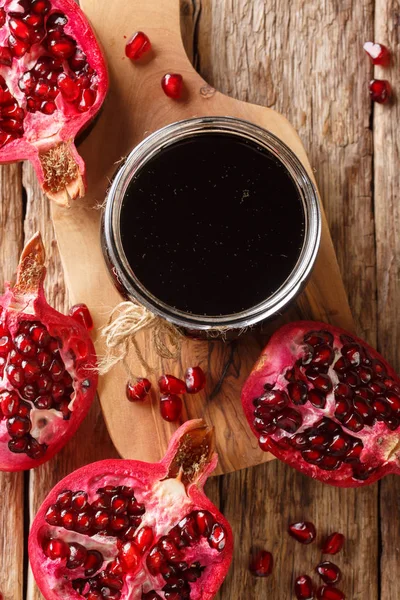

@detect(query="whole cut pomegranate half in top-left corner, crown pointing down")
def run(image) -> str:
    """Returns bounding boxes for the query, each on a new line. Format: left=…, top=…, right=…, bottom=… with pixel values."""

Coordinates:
left=0, top=0, right=108, bottom=205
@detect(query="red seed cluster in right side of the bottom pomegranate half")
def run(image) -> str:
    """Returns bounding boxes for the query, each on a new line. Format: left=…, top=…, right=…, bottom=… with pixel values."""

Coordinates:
left=142, top=510, right=226, bottom=600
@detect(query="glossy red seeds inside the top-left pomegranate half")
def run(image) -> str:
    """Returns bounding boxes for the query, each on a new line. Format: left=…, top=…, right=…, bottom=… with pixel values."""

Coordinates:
left=0, top=0, right=97, bottom=147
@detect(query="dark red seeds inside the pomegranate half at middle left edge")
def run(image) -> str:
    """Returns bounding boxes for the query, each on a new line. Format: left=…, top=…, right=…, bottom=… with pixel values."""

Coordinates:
left=0, top=321, right=74, bottom=459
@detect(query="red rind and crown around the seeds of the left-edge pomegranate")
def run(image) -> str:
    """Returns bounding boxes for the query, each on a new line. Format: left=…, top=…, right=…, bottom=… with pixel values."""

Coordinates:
left=0, top=233, right=97, bottom=471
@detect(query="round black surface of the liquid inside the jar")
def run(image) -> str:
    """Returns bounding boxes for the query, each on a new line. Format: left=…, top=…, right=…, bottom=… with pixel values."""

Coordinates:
left=121, top=133, right=305, bottom=316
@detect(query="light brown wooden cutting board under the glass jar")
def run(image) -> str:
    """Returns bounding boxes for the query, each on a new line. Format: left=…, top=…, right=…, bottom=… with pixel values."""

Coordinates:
left=52, top=0, right=353, bottom=473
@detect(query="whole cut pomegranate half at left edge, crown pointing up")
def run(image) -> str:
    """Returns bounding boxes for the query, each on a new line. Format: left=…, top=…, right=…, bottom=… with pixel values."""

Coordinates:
left=0, top=233, right=97, bottom=471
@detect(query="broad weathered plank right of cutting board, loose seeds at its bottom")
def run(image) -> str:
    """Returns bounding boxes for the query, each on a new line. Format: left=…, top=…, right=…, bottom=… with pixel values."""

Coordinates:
left=198, top=0, right=380, bottom=600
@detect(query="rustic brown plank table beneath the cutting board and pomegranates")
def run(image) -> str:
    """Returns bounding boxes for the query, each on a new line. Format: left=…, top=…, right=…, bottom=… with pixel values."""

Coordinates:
left=0, top=0, right=400, bottom=600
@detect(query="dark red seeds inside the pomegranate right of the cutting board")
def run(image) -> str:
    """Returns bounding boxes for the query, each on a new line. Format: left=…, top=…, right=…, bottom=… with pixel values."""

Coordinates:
left=253, top=331, right=400, bottom=479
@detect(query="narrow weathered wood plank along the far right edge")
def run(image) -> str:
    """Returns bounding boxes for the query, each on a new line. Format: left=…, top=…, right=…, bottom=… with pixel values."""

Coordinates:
left=373, top=0, right=400, bottom=599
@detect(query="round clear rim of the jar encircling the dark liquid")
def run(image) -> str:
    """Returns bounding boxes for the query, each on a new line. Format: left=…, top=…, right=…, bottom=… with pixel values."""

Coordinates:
left=103, top=117, right=321, bottom=331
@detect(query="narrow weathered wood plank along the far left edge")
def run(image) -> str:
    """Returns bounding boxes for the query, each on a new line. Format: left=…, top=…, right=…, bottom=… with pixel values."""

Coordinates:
left=0, top=165, right=24, bottom=600
